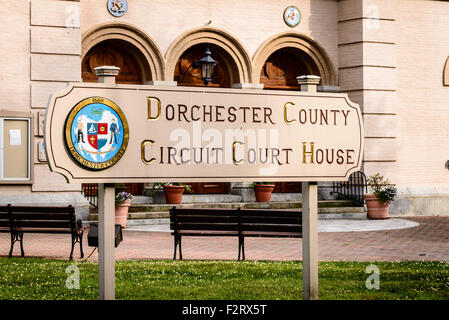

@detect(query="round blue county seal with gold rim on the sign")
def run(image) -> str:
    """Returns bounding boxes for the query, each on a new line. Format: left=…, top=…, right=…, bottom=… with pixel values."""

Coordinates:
left=65, top=97, right=129, bottom=170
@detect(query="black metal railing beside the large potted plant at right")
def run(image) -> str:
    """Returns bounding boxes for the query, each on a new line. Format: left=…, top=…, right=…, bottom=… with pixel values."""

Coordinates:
left=332, top=171, right=368, bottom=206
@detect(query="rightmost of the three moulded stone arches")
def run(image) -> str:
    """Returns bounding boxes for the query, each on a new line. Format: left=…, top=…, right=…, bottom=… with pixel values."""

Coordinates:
left=252, top=32, right=337, bottom=86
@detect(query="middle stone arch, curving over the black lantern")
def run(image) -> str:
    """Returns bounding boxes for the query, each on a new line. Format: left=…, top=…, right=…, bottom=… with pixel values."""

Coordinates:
left=165, top=27, right=252, bottom=83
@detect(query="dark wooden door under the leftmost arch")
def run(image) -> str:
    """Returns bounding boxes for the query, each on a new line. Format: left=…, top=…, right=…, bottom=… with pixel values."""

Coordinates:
left=81, top=42, right=145, bottom=195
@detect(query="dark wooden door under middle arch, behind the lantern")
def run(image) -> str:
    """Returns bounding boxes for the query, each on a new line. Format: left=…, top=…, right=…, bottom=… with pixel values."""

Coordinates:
left=174, top=44, right=231, bottom=194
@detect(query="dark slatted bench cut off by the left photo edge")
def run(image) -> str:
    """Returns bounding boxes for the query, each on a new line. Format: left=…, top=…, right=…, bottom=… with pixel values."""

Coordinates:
left=0, top=205, right=85, bottom=260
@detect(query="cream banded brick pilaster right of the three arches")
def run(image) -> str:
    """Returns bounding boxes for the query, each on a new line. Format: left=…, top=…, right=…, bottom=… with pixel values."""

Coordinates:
left=338, top=0, right=398, bottom=182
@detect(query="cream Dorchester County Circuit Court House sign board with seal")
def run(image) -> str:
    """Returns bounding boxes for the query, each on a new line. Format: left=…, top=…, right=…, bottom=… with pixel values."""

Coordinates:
left=45, top=83, right=364, bottom=183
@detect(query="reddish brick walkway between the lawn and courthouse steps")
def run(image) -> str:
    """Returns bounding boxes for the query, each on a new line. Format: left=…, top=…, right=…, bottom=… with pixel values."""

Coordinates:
left=0, top=216, right=449, bottom=261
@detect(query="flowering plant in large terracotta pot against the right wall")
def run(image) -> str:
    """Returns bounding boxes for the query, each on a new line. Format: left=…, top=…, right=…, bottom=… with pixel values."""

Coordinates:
left=363, top=173, right=397, bottom=219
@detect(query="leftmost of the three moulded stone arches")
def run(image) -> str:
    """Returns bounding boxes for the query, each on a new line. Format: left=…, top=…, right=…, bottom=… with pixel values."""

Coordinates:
left=81, top=23, right=165, bottom=81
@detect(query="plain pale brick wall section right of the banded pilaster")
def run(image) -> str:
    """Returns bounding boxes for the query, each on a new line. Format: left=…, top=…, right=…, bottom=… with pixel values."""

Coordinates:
left=397, top=0, right=449, bottom=187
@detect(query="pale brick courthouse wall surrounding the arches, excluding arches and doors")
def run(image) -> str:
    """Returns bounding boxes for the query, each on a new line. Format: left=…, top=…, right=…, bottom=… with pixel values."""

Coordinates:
left=0, top=0, right=449, bottom=215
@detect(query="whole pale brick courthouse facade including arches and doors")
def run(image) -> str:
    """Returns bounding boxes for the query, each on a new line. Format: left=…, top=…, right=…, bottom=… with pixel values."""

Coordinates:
left=0, top=0, right=449, bottom=219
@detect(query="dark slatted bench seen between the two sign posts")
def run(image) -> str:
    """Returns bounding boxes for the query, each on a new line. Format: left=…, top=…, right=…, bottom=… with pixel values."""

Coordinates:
left=170, top=207, right=302, bottom=260
